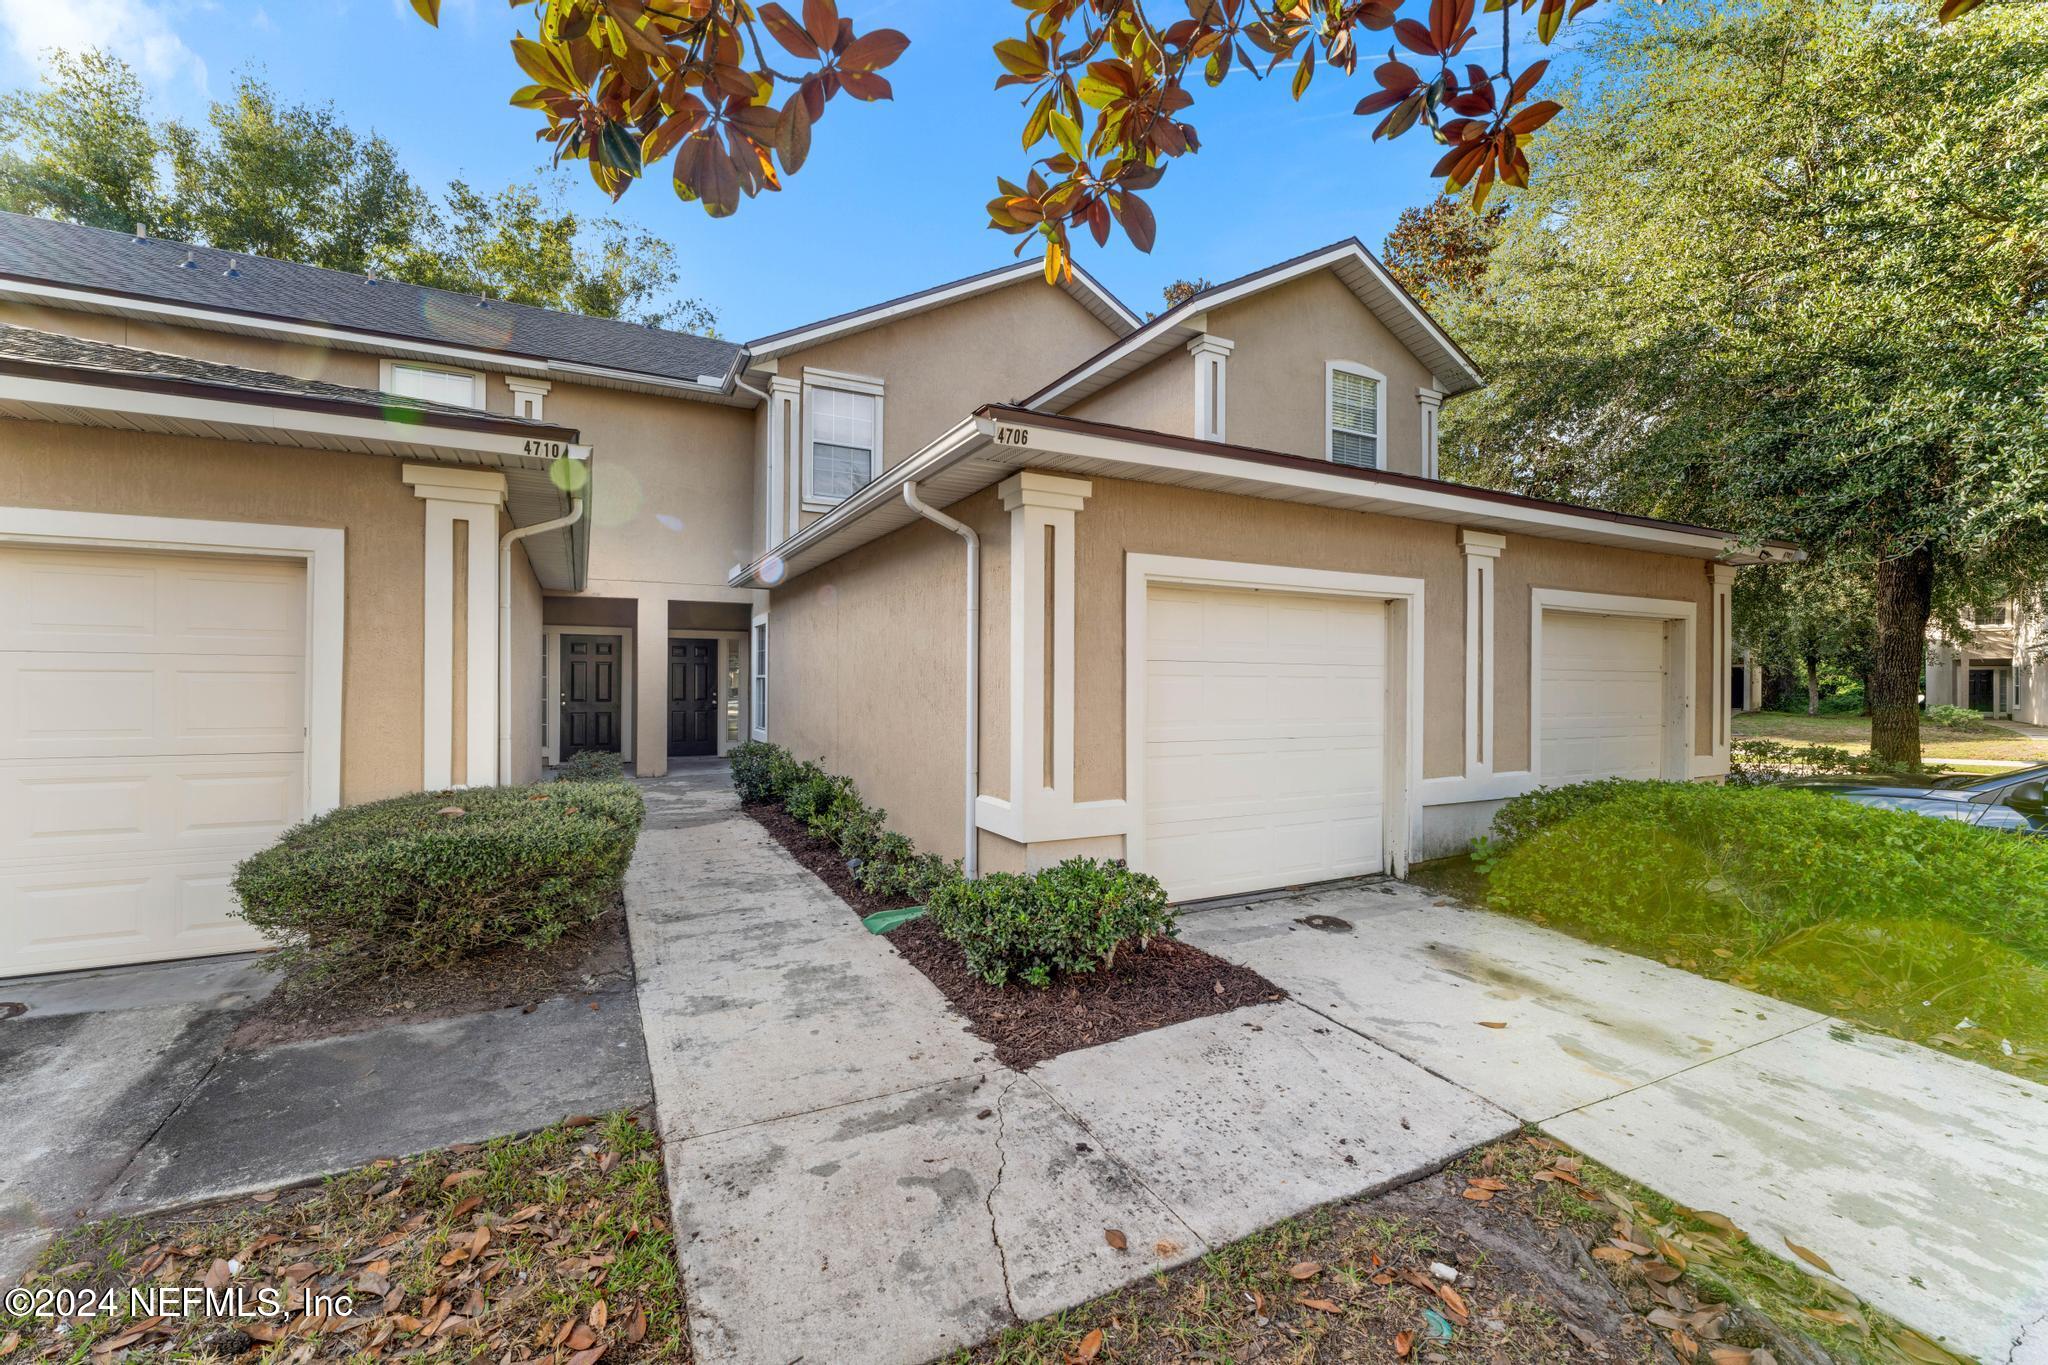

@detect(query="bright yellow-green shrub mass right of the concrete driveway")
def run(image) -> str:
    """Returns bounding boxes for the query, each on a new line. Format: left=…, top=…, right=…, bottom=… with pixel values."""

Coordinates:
left=1487, top=782, right=2048, bottom=964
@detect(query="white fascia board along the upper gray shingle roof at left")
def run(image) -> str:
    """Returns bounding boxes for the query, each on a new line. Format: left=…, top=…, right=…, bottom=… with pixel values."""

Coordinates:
left=0, top=280, right=731, bottom=397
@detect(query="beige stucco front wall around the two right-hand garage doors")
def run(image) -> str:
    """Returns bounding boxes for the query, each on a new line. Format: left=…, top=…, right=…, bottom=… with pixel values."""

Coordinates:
left=1075, top=479, right=1712, bottom=800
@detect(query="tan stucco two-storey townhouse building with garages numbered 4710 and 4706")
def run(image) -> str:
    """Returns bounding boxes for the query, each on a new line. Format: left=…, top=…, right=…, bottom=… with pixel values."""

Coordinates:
left=0, top=215, right=1790, bottom=974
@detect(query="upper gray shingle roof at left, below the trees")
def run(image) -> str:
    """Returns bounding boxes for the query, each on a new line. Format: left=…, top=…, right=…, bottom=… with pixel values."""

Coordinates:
left=0, top=213, right=739, bottom=383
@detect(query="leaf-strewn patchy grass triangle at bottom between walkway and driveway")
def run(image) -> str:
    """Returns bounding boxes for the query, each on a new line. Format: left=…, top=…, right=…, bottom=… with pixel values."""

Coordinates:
left=956, top=1134, right=1954, bottom=1365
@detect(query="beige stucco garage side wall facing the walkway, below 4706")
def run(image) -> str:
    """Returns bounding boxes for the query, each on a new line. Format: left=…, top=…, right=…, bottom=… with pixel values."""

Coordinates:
left=768, top=493, right=1010, bottom=857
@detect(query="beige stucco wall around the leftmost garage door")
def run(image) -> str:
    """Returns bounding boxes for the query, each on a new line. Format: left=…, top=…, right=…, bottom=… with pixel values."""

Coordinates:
left=0, top=422, right=426, bottom=802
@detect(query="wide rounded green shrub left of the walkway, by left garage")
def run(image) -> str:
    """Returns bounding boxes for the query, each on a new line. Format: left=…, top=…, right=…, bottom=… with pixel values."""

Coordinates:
left=233, top=780, right=643, bottom=994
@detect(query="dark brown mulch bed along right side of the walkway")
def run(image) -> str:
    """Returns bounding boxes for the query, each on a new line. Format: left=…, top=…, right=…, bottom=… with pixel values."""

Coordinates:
left=745, top=804, right=1286, bottom=1070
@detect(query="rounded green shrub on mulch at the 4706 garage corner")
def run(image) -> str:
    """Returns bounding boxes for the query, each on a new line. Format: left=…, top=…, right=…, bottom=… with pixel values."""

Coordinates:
left=928, top=857, right=1174, bottom=986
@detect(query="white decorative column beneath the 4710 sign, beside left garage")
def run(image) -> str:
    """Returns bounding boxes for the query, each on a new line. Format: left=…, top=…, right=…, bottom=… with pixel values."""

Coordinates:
left=401, top=465, right=506, bottom=792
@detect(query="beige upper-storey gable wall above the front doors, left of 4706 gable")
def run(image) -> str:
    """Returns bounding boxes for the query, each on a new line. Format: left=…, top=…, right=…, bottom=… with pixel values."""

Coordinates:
left=774, top=278, right=1116, bottom=524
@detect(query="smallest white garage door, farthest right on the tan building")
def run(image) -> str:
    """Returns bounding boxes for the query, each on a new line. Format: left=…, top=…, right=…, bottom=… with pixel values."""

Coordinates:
left=1540, top=612, right=1667, bottom=786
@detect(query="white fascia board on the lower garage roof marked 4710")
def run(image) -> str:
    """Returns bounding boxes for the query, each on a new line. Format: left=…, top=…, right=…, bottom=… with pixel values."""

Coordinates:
left=0, top=375, right=590, bottom=465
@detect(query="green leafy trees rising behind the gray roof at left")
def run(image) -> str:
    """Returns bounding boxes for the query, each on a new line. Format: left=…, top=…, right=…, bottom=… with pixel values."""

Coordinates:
left=0, top=51, right=717, bottom=332
